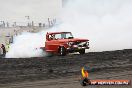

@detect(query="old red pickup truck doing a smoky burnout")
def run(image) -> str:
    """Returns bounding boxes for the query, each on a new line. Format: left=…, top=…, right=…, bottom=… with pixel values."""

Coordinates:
left=44, top=32, right=89, bottom=56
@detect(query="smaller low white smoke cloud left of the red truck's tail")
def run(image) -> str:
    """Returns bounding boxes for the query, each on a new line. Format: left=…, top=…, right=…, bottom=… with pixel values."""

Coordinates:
left=6, top=33, right=45, bottom=58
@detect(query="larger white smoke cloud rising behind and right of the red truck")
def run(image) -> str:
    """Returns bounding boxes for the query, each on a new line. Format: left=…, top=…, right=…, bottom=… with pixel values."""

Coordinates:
left=59, top=0, right=132, bottom=51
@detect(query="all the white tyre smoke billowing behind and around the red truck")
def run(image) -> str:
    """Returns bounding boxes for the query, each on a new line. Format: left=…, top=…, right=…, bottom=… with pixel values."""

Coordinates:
left=6, top=0, right=132, bottom=58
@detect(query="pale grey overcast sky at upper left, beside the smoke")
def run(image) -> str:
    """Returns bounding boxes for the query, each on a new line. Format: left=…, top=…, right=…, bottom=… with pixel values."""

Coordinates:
left=0, top=0, right=62, bottom=21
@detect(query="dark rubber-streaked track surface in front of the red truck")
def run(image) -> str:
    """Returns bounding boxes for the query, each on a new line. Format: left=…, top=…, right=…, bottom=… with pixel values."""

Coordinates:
left=0, top=49, right=132, bottom=88
